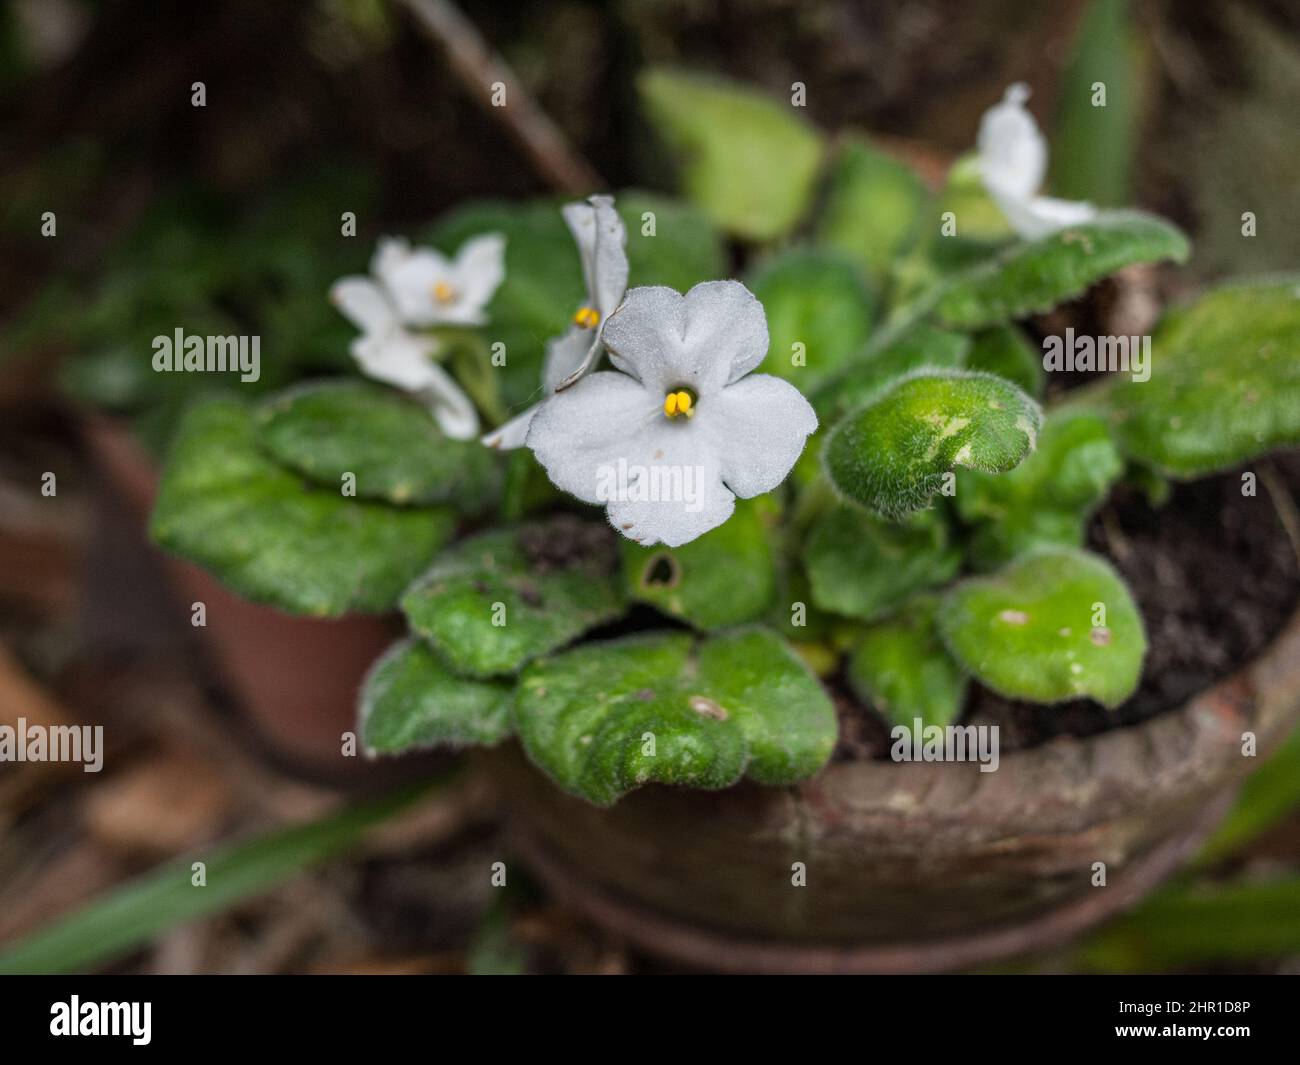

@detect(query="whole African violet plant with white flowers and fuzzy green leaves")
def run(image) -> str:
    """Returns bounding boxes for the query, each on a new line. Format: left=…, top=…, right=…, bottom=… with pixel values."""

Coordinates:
left=153, top=72, right=1300, bottom=804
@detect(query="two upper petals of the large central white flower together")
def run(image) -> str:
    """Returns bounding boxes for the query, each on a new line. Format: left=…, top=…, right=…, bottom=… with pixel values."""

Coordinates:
left=602, top=281, right=768, bottom=397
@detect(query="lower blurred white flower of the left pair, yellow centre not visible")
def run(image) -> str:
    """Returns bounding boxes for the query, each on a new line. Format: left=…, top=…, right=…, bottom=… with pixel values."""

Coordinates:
left=330, top=241, right=478, bottom=440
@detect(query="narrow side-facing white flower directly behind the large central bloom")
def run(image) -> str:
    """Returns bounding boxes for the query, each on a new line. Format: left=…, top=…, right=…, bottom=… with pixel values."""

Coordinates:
left=484, top=196, right=628, bottom=449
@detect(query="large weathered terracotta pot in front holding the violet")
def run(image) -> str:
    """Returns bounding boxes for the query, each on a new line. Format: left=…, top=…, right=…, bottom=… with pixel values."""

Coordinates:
left=490, top=615, right=1300, bottom=973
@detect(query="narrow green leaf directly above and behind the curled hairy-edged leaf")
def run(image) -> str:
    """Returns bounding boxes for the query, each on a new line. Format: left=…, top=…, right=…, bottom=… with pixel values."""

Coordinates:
left=813, top=322, right=971, bottom=419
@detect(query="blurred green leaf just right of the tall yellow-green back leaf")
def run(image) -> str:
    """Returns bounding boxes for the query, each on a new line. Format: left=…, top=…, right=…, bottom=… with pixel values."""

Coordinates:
left=818, top=140, right=930, bottom=290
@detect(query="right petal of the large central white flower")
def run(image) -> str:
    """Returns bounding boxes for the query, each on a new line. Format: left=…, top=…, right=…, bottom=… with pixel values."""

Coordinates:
left=694, top=373, right=816, bottom=499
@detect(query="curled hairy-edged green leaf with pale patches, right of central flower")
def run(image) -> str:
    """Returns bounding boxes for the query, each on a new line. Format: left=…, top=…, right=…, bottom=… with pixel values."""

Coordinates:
left=824, top=369, right=1043, bottom=519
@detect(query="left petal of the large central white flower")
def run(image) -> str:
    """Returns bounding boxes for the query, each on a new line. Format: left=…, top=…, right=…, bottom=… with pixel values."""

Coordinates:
left=528, top=371, right=666, bottom=503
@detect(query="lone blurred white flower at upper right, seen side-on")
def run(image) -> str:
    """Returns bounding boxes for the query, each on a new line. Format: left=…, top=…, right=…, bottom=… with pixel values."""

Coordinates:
left=979, top=82, right=1097, bottom=241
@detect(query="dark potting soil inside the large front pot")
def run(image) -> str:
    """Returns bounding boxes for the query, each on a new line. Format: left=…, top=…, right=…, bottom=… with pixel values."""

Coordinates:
left=835, top=453, right=1300, bottom=761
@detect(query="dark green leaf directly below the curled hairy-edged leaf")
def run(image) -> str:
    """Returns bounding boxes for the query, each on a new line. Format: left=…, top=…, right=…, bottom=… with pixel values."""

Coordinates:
left=803, top=506, right=962, bottom=622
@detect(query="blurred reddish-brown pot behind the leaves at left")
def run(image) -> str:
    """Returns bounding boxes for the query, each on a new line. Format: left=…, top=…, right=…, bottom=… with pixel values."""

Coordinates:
left=85, top=416, right=400, bottom=779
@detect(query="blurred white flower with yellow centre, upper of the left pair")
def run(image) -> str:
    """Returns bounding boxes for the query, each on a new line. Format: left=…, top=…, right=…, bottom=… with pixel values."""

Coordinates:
left=372, top=233, right=506, bottom=325
